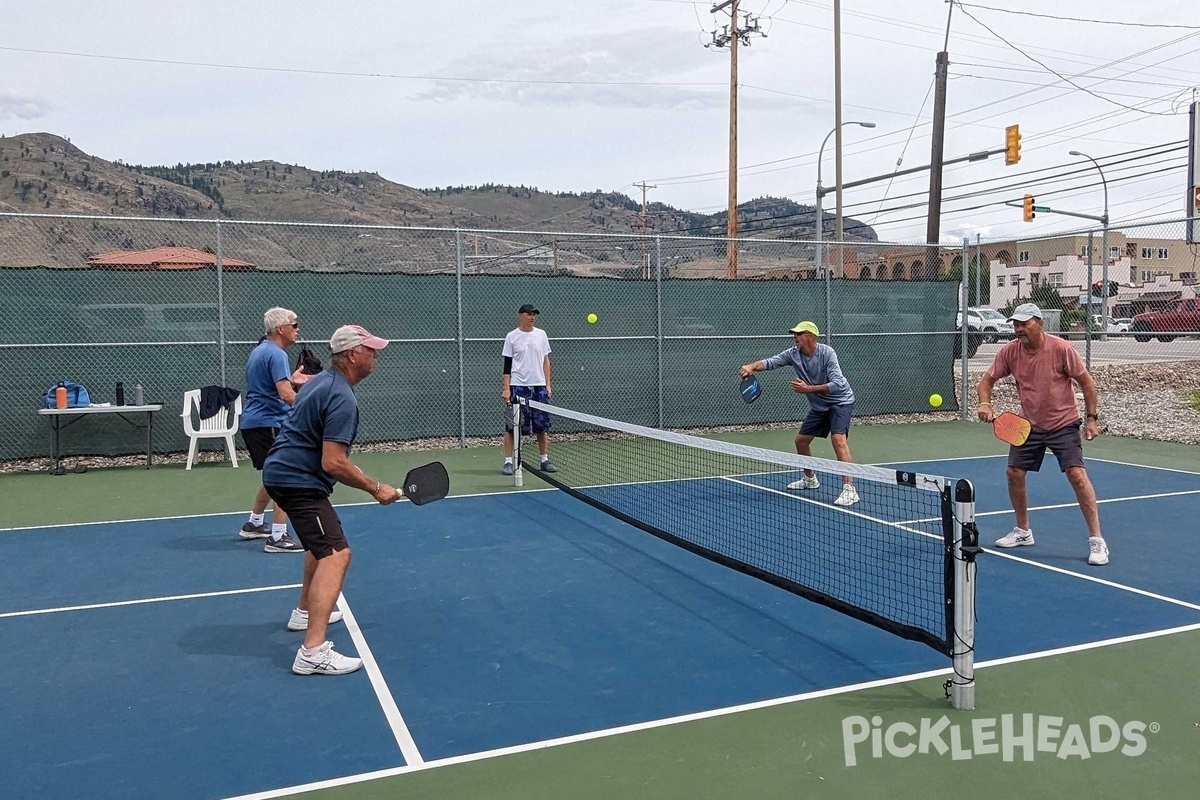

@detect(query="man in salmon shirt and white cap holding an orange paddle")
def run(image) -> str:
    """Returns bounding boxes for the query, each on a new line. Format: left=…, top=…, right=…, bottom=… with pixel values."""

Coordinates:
left=979, top=302, right=1109, bottom=566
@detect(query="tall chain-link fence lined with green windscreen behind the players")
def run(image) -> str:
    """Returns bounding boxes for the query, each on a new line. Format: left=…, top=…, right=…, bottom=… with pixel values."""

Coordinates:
left=25, top=215, right=1190, bottom=470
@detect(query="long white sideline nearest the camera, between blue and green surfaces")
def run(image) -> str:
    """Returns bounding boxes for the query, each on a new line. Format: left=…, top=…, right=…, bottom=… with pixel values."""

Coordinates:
left=211, top=622, right=1200, bottom=800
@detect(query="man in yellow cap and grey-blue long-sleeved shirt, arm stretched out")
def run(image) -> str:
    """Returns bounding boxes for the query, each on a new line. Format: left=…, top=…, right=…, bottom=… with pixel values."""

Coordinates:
left=739, top=320, right=858, bottom=506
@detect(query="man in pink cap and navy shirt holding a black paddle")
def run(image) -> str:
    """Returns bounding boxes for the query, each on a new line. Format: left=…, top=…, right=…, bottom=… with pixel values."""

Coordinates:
left=263, top=325, right=403, bottom=675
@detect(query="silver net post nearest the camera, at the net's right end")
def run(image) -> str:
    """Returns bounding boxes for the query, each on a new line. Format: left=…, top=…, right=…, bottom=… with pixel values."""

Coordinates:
left=949, top=480, right=983, bottom=711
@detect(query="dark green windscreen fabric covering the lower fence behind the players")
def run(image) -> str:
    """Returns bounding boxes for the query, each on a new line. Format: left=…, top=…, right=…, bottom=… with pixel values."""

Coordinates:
left=0, top=267, right=958, bottom=459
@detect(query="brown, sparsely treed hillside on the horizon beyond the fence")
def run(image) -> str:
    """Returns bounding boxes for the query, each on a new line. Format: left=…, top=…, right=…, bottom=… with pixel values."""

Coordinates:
left=0, top=133, right=876, bottom=271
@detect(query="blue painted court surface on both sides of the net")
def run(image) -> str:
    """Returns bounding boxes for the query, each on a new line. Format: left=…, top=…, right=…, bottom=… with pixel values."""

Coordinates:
left=0, top=458, right=1200, bottom=800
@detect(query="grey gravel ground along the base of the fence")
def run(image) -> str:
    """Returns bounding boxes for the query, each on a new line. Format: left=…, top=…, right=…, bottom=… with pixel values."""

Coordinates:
left=0, top=361, right=1200, bottom=474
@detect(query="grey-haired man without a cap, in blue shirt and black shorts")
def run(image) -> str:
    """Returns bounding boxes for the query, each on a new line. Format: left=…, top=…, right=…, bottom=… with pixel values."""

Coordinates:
left=238, top=307, right=308, bottom=553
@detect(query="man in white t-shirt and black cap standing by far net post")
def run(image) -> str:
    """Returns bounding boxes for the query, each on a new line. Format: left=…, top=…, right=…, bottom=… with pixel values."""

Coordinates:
left=500, top=303, right=558, bottom=475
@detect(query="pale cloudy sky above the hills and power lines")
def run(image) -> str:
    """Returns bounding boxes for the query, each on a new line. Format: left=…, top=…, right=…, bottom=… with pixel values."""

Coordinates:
left=0, top=0, right=1200, bottom=242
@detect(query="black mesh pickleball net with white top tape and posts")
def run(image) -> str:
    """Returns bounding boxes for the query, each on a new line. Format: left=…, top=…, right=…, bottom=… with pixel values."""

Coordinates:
left=512, top=399, right=979, bottom=708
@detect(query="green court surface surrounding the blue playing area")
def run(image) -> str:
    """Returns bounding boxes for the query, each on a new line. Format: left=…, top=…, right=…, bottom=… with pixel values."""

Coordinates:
left=9, top=422, right=1200, bottom=800
